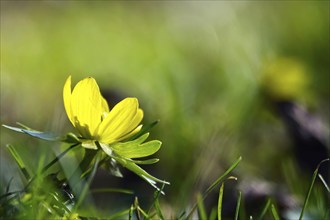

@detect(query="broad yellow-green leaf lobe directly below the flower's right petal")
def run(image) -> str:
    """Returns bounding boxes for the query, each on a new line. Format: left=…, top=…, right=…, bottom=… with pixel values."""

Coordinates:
left=110, top=133, right=162, bottom=158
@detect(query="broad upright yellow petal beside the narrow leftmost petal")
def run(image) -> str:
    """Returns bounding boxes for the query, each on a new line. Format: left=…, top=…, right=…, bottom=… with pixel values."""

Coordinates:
left=71, top=77, right=103, bottom=138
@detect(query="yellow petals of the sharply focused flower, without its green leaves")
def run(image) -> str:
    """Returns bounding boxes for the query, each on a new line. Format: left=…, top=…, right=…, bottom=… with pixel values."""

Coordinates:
left=63, top=76, right=143, bottom=149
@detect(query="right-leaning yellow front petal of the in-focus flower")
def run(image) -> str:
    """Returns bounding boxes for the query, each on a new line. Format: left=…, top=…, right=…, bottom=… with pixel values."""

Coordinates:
left=97, top=98, right=143, bottom=144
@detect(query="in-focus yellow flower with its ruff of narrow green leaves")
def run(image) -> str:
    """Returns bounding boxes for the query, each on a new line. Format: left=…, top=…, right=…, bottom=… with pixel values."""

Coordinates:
left=3, top=76, right=170, bottom=193
